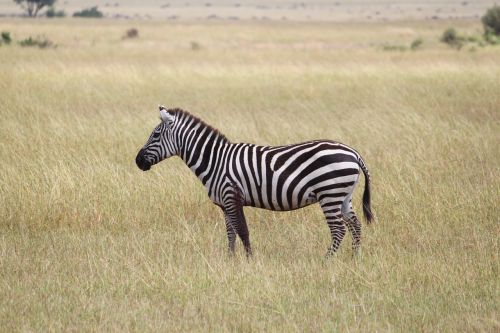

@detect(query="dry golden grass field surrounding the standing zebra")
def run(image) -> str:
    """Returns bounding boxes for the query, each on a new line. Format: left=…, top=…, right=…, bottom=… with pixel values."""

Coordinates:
left=0, top=19, right=500, bottom=332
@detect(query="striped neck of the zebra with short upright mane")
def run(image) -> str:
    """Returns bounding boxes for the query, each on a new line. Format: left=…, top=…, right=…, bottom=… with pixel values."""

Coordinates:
left=176, top=110, right=230, bottom=185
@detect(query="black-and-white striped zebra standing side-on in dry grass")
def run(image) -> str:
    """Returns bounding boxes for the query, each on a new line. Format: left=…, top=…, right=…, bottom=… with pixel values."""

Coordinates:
left=135, top=106, right=373, bottom=256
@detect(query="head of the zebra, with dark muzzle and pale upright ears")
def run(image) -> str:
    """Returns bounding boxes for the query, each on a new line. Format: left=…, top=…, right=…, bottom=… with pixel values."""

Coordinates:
left=135, top=106, right=177, bottom=171
